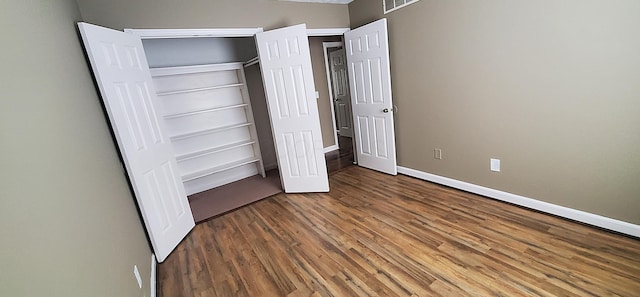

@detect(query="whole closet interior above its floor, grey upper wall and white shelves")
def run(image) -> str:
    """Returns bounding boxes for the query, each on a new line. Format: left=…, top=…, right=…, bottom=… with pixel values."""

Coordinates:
left=143, top=37, right=277, bottom=195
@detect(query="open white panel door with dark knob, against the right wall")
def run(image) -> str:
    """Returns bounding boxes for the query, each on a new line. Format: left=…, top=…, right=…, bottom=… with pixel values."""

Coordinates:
left=344, top=19, right=398, bottom=175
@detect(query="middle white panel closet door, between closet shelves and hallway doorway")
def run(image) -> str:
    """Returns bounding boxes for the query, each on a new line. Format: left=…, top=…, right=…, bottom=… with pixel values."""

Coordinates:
left=256, top=25, right=329, bottom=193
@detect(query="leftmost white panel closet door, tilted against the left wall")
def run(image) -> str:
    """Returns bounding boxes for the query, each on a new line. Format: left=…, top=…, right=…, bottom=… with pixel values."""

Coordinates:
left=78, top=23, right=195, bottom=262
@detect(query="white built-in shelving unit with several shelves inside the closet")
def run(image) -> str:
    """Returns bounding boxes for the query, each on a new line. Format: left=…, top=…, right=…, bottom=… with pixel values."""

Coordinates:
left=151, top=63, right=265, bottom=195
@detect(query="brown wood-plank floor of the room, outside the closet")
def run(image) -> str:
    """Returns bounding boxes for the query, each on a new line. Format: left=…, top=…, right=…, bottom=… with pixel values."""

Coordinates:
left=158, top=166, right=640, bottom=297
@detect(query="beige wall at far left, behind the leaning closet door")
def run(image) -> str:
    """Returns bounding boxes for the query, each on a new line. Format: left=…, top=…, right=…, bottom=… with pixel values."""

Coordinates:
left=0, top=0, right=151, bottom=297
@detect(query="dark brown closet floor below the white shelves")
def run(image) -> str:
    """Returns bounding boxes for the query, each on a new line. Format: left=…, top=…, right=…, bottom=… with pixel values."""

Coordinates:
left=189, top=169, right=282, bottom=223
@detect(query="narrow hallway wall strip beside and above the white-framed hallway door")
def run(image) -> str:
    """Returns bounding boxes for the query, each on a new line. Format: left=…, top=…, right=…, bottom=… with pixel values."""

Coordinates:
left=309, top=37, right=342, bottom=147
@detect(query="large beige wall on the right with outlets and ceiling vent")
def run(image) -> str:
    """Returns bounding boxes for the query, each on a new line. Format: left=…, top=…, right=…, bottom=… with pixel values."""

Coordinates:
left=349, top=0, right=640, bottom=224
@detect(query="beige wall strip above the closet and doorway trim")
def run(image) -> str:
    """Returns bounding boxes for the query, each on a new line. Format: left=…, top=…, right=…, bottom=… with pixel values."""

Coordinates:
left=78, top=0, right=349, bottom=29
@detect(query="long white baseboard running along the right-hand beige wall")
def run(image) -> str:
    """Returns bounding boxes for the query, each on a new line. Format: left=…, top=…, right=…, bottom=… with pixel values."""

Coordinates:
left=398, top=166, right=640, bottom=237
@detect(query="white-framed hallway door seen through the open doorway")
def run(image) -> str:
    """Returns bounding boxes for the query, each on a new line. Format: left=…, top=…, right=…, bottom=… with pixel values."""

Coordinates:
left=329, top=48, right=353, bottom=137
